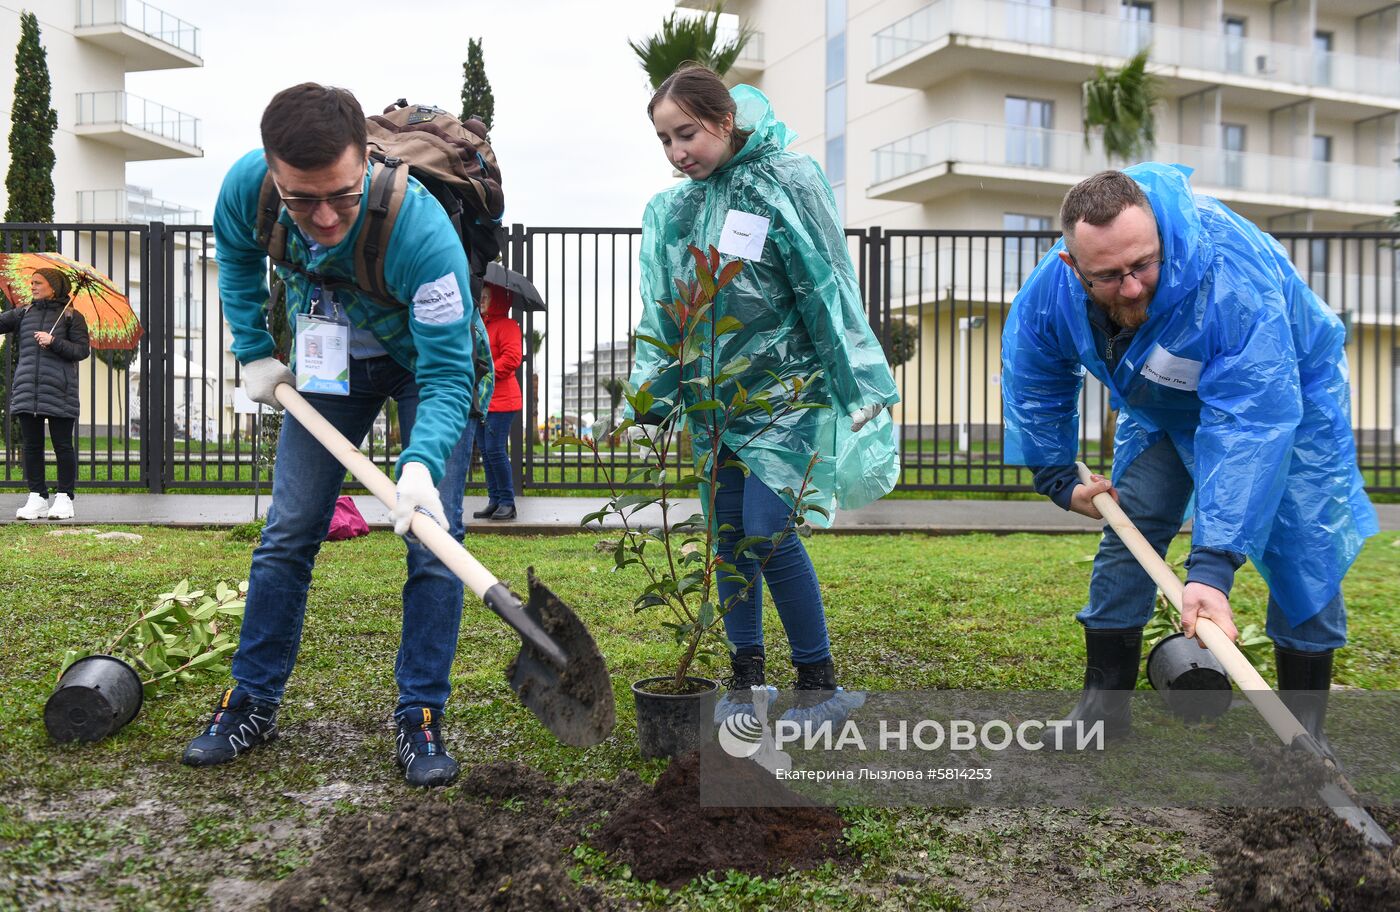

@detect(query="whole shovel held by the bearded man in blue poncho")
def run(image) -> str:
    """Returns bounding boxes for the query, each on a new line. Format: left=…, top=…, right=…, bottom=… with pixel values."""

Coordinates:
left=1075, top=462, right=1393, bottom=849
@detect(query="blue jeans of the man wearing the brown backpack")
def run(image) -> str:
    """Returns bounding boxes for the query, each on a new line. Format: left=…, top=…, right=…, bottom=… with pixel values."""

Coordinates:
left=232, top=357, right=473, bottom=713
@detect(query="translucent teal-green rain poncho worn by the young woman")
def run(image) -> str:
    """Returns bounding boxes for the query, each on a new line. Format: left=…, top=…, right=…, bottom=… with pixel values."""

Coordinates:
left=631, top=85, right=899, bottom=527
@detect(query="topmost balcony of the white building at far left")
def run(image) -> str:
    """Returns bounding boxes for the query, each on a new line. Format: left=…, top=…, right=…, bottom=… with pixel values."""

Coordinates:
left=73, top=0, right=204, bottom=73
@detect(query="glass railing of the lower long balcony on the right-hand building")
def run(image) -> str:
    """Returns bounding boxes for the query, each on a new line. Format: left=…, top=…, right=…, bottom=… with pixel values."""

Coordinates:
left=874, top=120, right=1400, bottom=207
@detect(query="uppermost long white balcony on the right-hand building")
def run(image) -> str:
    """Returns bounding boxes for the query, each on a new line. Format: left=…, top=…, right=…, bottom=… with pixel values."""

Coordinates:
left=867, top=0, right=1400, bottom=113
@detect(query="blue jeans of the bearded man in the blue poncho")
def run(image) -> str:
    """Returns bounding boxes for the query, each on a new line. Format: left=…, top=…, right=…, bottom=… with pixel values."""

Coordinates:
left=1077, top=437, right=1347, bottom=653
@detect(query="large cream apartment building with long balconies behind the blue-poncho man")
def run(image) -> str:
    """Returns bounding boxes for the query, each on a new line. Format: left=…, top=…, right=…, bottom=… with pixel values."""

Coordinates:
left=678, top=0, right=1400, bottom=448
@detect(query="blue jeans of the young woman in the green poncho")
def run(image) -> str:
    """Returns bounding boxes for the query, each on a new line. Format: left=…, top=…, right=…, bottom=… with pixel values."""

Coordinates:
left=713, top=450, right=832, bottom=664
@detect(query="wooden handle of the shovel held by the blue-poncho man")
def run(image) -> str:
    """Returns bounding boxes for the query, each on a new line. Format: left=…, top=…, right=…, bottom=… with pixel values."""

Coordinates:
left=1075, top=462, right=1306, bottom=744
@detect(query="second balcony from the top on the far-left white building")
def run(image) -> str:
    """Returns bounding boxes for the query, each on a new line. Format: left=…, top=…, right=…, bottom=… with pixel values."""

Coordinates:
left=74, top=91, right=204, bottom=161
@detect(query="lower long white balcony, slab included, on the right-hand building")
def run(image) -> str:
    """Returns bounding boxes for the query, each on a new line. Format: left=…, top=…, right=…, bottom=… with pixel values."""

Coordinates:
left=867, top=120, right=1400, bottom=219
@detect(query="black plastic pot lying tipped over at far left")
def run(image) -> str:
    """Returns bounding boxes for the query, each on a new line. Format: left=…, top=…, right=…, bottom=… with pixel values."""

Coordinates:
left=43, top=656, right=143, bottom=741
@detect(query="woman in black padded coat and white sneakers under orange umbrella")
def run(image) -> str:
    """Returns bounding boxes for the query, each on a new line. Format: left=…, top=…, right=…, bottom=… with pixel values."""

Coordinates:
left=0, top=268, right=91, bottom=520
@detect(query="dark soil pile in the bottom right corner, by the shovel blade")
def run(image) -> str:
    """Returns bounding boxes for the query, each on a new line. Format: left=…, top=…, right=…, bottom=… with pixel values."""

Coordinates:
left=1212, top=748, right=1400, bottom=912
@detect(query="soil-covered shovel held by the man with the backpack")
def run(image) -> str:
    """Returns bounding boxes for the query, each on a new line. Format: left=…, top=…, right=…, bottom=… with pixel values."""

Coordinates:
left=276, top=384, right=615, bottom=747
